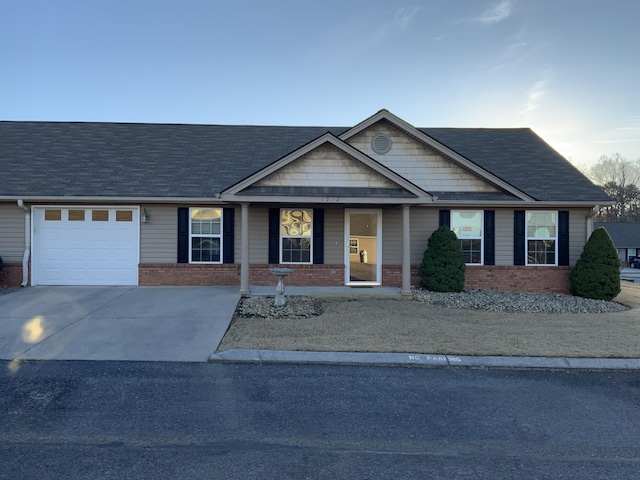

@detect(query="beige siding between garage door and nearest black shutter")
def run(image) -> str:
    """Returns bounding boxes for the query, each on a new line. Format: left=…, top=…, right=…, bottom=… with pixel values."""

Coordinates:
left=140, top=205, right=178, bottom=263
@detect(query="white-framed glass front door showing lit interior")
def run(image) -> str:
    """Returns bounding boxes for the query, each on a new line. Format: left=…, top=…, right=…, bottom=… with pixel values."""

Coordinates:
left=344, top=209, right=382, bottom=285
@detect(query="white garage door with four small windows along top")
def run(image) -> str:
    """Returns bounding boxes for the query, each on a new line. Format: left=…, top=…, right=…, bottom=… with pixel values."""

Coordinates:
left=31, top=207, right=140, bottom=285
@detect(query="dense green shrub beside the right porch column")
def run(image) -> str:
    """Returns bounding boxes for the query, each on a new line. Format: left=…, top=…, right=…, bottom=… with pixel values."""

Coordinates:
left=418, top=226, right=466, bottom=292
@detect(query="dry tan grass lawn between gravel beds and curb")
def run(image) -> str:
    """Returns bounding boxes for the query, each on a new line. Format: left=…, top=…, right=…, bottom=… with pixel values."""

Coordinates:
left=218, top=285, right=640, bottom=358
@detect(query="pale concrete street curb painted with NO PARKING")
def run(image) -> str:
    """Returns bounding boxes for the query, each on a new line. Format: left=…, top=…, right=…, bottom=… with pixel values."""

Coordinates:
left=209, top=350, right=640, bottom=370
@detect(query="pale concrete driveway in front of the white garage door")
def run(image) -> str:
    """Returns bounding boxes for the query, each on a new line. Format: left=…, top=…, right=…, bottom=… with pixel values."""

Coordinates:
left=0, top=287, right=240, bottom=362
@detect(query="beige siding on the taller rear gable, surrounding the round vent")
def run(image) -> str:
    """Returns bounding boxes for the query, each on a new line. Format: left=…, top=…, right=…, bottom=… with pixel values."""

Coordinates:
left=347, top=122, right=498, bottom=192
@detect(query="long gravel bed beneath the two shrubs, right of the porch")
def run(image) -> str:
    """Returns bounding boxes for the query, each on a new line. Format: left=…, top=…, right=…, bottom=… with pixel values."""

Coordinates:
left=412, top=289, right=627, bottom=313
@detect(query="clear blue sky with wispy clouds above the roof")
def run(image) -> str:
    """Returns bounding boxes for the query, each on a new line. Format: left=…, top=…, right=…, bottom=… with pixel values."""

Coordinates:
left=0, top=0, right=640, bottom=166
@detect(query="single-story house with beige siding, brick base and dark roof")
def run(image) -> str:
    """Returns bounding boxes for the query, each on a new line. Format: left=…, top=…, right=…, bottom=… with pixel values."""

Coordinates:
left=0, top=110, right=611, bottom=294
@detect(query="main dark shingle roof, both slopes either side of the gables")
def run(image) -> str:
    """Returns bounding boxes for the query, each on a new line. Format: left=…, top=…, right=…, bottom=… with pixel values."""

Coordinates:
left=0, top=122, right=608, bottom=202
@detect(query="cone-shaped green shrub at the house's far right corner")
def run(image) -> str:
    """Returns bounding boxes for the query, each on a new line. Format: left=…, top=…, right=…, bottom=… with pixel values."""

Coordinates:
left=569, top=227, right=620, bottom=300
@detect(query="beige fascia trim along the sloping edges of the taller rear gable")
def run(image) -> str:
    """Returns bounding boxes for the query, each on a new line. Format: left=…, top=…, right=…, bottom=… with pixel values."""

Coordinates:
left=338, top=110, right=534, bottom=201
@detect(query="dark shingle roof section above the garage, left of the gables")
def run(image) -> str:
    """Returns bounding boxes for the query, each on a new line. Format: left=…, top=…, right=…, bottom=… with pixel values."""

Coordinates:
left=0, top=122, right=345, bottom=198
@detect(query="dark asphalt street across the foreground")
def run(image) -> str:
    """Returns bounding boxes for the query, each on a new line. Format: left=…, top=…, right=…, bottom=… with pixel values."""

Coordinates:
left=0, top=361, right=640, bottom=479
